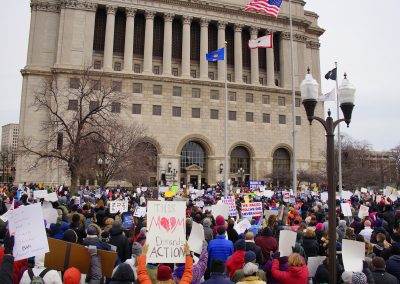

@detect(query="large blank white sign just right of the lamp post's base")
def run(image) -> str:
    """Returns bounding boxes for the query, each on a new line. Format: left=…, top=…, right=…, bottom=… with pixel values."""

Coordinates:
left=342, top=239, right=365, bottom=272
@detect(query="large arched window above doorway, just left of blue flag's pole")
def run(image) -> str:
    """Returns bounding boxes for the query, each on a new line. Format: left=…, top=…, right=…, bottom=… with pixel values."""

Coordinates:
left=181, top=141, right=207, bottom=173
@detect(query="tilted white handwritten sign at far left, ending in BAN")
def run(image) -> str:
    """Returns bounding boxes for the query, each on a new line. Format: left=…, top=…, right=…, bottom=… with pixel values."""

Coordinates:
left=8, top=203, right=49, bottom=261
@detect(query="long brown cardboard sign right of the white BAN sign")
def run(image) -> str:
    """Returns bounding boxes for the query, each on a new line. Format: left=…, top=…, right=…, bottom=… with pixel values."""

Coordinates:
left=44, top=238, right=117, bottom=278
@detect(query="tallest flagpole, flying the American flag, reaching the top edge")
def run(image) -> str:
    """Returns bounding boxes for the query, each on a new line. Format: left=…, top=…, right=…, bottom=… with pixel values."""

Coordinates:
left=289, top=0, right=297, bottom=196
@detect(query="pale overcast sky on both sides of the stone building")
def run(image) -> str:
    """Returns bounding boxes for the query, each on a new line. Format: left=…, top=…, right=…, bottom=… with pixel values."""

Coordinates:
left=0, top=0, right=400, bottom=150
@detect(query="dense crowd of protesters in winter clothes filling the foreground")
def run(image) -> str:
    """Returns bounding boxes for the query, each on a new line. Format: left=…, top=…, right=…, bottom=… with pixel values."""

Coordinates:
left=0, top=185, right=400, bottom=284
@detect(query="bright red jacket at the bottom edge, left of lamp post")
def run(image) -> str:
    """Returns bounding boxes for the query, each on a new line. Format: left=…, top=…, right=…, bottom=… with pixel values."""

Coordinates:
left=271, top=259, right=308, bottom=284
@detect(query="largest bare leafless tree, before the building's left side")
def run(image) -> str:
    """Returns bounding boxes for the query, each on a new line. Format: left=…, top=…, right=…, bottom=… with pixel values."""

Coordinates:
left=20, top=68, right=124, bottom=191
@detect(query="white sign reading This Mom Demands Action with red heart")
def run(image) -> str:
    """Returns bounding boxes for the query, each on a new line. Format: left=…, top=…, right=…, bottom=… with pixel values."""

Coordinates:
left=146, top=201, right=186, bottom=263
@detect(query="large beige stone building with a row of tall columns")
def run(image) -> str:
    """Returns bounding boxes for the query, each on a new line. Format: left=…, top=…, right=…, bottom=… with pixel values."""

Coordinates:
left=16, top=0, right=325, bottom=189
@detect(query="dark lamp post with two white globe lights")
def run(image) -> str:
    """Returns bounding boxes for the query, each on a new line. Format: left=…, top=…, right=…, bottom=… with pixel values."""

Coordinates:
left=300, top=68, right=356, bottom=283
